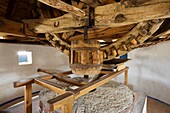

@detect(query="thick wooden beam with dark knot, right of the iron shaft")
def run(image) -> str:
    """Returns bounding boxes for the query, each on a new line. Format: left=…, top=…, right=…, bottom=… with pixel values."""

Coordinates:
left=95, top=0, right=170, bottom=27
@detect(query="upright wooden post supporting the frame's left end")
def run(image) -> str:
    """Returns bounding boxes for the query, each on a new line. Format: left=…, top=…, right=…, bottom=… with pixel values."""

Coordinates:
left=24, top=84, right=32, bottom=113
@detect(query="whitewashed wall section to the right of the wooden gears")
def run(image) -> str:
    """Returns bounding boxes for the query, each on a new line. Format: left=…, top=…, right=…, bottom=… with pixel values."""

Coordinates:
left=117, top=42, right=170, bottom=104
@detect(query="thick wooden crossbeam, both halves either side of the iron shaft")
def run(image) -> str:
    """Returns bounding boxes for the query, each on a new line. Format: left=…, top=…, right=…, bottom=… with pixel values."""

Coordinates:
left=24, top=0, right=170, bottom=33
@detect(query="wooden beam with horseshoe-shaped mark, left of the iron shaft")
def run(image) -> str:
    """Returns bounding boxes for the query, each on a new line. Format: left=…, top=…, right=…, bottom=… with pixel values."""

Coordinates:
left=23, top=14, right=85, bottom=33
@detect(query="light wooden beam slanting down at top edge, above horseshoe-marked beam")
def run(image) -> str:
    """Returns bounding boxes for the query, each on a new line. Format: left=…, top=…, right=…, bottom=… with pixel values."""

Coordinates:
left=38, top=0, right=85, bottom=17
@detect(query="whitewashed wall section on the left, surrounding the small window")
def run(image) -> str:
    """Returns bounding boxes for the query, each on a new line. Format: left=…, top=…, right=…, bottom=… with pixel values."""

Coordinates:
left=0, top=43, right=69, bottom=104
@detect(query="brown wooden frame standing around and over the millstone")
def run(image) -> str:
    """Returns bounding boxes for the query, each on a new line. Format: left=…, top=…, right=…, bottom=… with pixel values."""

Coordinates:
left=14, top=67, right=128, bottom=113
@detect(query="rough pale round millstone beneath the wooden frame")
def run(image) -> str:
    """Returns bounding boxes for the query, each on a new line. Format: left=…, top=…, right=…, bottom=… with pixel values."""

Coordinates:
left=39, top=81, right=134, bottom=113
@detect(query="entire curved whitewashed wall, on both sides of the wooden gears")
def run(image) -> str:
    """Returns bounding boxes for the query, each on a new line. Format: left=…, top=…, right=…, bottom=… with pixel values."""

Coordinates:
left=0, top=42, right=170, bottom=104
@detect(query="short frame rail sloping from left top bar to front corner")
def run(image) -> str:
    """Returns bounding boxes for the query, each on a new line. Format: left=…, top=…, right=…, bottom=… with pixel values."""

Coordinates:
left=34, top=78, right=65, bottom=94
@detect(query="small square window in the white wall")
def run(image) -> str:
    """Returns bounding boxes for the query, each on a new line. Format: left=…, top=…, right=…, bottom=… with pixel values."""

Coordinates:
left=18, top=51, right=32, bottom=65
